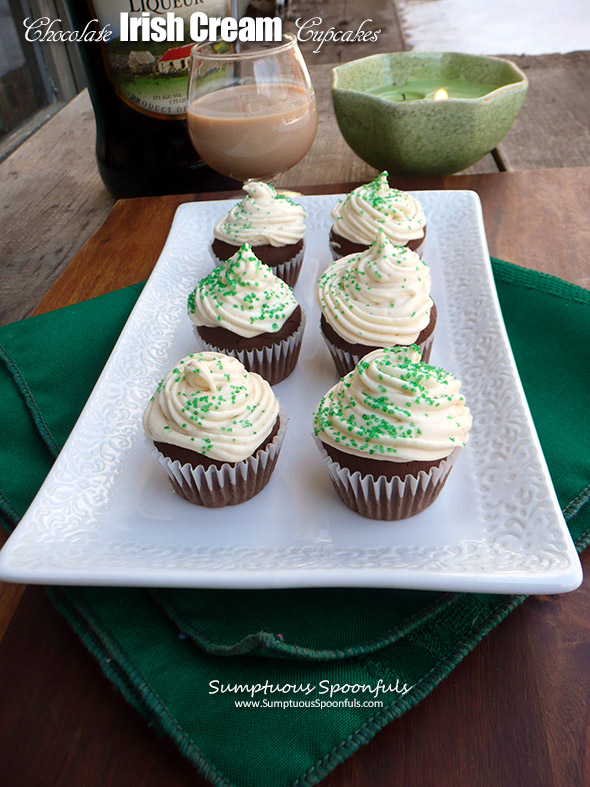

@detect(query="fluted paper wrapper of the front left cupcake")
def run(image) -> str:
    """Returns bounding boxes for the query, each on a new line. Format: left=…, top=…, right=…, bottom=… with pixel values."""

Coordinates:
left=152, top=407, right=288, bottom=508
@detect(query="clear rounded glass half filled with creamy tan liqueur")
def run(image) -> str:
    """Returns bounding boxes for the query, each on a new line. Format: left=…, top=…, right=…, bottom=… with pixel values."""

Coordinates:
left=188, top=33, right=318, bottom=182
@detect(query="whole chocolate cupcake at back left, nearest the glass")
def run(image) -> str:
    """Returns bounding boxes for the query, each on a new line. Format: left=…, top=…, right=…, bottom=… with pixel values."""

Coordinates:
left=211, top=183, right=305, bottom=287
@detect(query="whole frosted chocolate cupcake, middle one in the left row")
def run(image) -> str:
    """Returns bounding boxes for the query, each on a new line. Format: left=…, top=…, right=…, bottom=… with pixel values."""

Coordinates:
left=188, top=243, right=305, bottom=385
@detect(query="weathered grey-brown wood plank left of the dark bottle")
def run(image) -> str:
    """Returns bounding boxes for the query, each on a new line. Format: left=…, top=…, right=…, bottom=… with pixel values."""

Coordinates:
left=0, top=91, right=114, bottom=323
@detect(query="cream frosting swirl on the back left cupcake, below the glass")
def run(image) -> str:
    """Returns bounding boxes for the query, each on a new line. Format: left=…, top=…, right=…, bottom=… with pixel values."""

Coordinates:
left=213, top=182, right=305, bottom=246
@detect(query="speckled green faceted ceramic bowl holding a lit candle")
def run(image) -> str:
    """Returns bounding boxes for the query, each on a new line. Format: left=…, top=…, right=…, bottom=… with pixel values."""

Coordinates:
left=332, top=52, right=528, bottom=175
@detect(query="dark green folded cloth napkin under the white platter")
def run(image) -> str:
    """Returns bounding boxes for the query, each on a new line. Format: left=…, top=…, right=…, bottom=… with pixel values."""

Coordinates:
left=0, top=260, right=590, bottom=787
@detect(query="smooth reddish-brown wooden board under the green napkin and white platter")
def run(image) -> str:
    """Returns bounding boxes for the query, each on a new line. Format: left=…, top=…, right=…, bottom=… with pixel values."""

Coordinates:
left=0, top=168, right=590, bottom=787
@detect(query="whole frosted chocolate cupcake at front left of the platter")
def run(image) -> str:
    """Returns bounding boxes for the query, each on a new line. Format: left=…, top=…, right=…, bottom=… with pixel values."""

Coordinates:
left=143, top=352, right=287, bottom=508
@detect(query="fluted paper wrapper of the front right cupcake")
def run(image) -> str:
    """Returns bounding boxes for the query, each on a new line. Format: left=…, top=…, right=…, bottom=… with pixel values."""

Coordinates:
left=314, top=435, right=461, bottom=521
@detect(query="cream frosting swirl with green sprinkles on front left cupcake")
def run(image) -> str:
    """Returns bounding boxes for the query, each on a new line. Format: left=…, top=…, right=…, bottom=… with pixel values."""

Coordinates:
left=143, top=352, right=279, bottom=462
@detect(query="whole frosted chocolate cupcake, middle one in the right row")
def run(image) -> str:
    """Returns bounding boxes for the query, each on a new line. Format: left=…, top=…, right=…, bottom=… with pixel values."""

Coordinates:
left=317, top=230, right=436, bottom=376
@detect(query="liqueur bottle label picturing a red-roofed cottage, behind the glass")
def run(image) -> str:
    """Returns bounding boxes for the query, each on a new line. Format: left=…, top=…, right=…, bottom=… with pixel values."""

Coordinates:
left=90, top=0, right=229, bottom=119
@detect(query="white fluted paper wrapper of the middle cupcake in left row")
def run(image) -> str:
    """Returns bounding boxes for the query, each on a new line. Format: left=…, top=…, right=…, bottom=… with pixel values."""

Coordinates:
left=193, top=309, right=306, bottom=385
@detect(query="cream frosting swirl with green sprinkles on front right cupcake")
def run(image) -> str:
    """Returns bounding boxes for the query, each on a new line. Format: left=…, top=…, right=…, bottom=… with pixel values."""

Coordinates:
left=314, top=345, right=472, bottom=462
